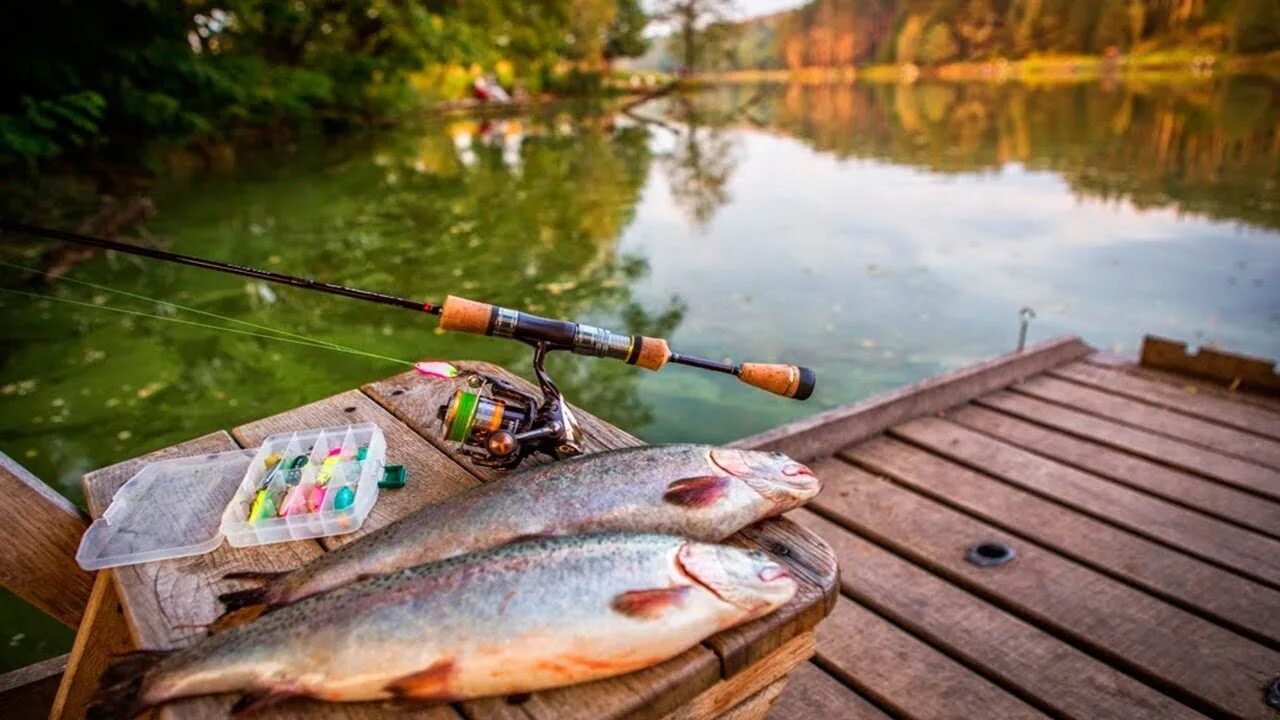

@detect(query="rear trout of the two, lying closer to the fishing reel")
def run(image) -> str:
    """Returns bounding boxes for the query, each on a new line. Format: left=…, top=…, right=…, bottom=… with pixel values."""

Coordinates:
left=212, top=445, right=822, bottom=622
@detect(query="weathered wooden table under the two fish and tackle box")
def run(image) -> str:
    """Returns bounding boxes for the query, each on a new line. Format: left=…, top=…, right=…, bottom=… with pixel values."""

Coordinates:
left=80, top=363, right=838, bottom=720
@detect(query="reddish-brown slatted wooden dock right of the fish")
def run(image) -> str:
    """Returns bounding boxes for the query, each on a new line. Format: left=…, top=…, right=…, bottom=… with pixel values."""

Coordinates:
left=737, top=338, right=1280, bottom=720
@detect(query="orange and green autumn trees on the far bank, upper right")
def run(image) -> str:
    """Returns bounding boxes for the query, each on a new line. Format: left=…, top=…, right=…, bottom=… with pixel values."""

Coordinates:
left=672, top=0, right=1280, bottom=69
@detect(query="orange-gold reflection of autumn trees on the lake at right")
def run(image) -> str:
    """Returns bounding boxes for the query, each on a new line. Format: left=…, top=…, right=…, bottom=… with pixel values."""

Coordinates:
left=701, top=77, right=1280, bottom=228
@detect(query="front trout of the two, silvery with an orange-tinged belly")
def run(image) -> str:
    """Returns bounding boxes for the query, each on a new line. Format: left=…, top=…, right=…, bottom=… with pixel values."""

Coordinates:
left=90, top=534, right=796, bottom=717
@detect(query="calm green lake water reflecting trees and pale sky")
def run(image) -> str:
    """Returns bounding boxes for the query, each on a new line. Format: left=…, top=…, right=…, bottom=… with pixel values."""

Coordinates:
left=0, top=79, right=1280, bottom=669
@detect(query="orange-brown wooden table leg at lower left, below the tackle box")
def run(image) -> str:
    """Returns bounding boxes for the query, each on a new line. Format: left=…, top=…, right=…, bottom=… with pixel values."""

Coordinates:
left=49, top=571, right=137, bottom=720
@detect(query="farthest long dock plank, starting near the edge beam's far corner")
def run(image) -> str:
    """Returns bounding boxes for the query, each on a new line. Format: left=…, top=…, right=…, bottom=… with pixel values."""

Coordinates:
left=1050, top=361, right=1280, bottom=439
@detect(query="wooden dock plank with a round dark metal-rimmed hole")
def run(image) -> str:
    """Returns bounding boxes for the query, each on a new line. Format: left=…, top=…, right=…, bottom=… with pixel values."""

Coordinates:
left=810, top=459, right=1280, bottom=720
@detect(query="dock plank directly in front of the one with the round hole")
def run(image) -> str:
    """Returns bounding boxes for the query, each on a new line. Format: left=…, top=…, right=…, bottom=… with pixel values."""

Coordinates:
left=787, top=509, right=1201, bottom=720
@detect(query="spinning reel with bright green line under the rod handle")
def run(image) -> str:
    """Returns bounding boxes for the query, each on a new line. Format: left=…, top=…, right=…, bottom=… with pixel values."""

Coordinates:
left=436, top=342, right=582, bottom=470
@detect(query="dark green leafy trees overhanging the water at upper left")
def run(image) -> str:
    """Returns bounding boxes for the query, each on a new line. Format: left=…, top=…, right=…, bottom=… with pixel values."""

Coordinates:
left=0, top=0, right=646, bottom=170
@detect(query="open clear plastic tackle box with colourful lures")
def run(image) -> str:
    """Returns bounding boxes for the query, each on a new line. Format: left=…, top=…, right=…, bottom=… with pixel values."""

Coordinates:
left=76, top=423, right=387, bottom=570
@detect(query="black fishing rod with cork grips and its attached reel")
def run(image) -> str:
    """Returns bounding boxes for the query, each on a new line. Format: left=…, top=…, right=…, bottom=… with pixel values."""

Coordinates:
left=0, top=219, right=817, bottom=466
